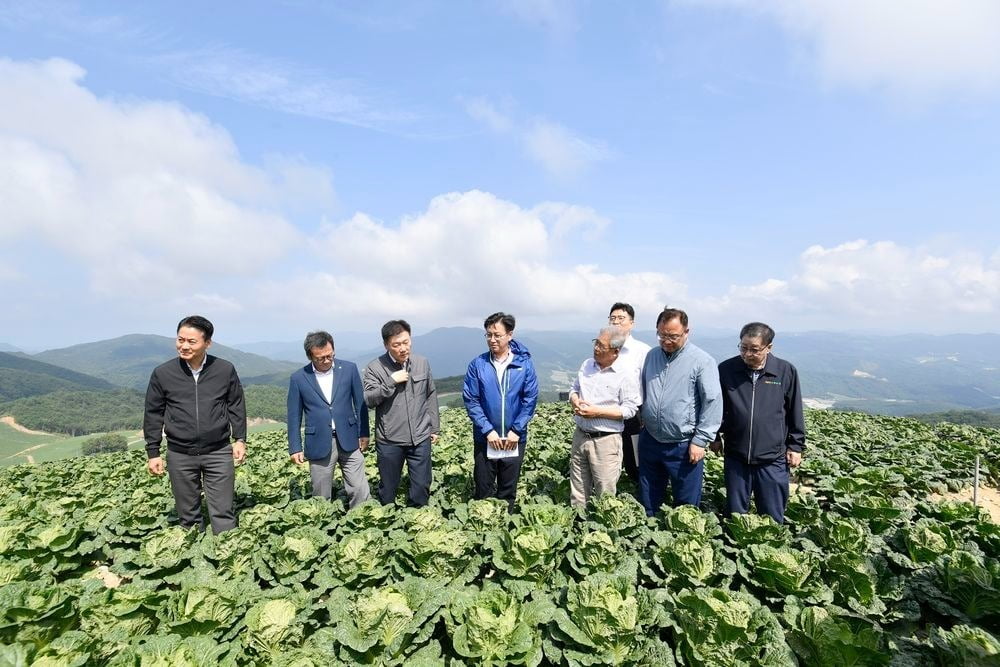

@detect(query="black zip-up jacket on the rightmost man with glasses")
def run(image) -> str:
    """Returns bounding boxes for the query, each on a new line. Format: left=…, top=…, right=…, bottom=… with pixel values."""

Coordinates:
left=719, top=354, right=806, bottom=465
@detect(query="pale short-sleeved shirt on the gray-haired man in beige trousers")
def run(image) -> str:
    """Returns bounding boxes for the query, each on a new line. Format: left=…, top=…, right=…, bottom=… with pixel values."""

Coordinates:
left=572, top=358, right=641, bottom=433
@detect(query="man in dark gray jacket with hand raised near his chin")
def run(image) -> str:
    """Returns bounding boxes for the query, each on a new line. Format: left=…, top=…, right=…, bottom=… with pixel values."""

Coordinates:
left=363, top=320, right=441, bottom=507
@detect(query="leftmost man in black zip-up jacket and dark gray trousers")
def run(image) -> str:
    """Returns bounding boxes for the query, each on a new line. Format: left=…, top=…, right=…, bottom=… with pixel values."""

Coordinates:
left=142, top=315, right=247, bottom=534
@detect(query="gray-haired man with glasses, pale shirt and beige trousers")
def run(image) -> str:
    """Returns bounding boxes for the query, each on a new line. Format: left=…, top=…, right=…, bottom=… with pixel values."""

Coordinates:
left=569, top=327, right=639, bottom=506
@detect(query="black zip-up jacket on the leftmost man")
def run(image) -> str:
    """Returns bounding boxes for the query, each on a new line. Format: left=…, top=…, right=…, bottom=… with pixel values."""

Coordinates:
left=142, top=355, right=247, bottom=458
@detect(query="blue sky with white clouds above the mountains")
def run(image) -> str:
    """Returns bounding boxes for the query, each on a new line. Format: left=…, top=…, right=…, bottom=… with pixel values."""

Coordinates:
left=0, top=0, right=1000, bottom=349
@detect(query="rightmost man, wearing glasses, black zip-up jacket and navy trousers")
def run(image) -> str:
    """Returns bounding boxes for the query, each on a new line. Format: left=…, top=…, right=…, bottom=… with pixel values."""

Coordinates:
left=712, top=322, right=806, bottom=523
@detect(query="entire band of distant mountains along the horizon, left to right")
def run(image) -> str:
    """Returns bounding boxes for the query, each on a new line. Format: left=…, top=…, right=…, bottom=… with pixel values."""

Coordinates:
left=0, top=327, right=1000, bottom=414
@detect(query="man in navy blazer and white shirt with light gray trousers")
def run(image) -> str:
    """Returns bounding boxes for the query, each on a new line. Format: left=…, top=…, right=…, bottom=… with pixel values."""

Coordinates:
left=288, top=331, right=371, bottom=507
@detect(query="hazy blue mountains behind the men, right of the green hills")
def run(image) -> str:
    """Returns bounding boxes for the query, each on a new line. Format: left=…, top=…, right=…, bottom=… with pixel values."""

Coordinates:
left=270, top=327, right=1000, bottom=414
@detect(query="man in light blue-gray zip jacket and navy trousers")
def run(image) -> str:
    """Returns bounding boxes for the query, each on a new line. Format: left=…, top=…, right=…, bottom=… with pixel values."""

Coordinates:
left=639, top=308, right=722, bottom=516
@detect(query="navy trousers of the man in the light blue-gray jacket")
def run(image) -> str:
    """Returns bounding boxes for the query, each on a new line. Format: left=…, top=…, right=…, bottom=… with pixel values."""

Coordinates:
left=639, top=429, right=705, bottom=516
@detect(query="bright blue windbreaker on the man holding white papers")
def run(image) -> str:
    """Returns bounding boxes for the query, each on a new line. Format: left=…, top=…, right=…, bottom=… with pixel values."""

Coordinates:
left=462, top=340, right=538, bottom=443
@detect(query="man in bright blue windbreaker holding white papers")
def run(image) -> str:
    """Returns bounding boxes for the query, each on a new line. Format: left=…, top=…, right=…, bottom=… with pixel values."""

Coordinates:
left=462, top=313, right=538, bottom=511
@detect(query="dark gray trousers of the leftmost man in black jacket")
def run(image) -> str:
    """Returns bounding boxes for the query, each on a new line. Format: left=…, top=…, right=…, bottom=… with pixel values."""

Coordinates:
left=167, top=445, right=236, bottom=535
